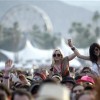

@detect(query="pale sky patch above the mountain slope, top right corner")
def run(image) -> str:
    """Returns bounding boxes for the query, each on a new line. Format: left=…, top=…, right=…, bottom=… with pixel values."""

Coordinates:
left=60, top=0, right=100, bottom=12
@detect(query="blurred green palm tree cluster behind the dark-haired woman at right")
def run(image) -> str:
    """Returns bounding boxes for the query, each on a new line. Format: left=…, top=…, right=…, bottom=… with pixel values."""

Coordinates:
left=69, top=12, right=100, bottom=48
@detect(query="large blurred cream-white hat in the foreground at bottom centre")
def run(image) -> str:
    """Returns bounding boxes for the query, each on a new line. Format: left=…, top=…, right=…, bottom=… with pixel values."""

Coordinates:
left=37, top=83, right=70, bottom=100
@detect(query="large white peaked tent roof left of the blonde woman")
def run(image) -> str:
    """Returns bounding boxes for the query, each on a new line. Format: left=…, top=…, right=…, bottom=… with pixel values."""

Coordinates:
left=18, top=41, right=53, bottom=60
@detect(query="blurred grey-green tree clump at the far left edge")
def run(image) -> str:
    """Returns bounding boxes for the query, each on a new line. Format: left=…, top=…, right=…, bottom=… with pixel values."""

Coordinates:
left=0, top=22, right=25, bottom=52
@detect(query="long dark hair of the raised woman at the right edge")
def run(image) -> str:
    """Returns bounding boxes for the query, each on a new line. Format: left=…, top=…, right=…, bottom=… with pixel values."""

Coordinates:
left=89, top=43, right=100, bottom=63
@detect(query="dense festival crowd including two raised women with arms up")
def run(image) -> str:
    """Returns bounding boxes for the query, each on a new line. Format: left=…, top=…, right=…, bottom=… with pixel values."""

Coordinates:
left=0, top=39, right=100, bottom=100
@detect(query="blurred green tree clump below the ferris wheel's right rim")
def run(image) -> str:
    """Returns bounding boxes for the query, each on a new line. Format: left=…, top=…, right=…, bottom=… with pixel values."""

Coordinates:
left=30, top=25, right=61, bottom=49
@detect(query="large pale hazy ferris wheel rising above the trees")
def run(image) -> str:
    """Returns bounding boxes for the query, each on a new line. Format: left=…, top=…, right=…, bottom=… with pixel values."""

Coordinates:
left=0, top=4, right=53, bottom=33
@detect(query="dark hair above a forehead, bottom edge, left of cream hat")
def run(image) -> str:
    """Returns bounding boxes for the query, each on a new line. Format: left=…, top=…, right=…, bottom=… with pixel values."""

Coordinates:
left=11, top=89, right=32, bottom=100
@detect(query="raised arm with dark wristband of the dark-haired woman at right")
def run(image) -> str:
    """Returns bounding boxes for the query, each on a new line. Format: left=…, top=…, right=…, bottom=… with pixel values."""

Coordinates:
left=68, top=39, right=90, bottom=60
